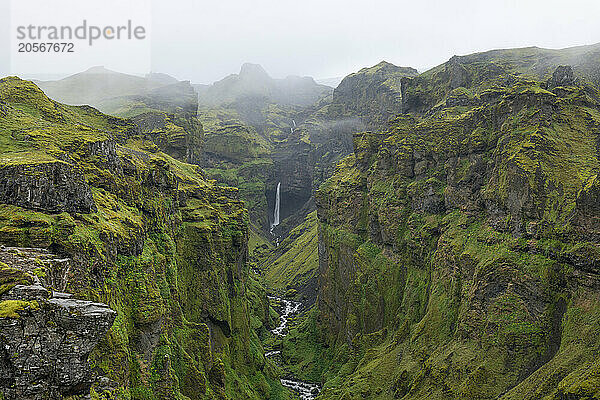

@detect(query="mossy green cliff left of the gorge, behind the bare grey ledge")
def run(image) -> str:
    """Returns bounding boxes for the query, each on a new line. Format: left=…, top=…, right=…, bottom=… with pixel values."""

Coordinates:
left=0, top=77, right=282, bottom=399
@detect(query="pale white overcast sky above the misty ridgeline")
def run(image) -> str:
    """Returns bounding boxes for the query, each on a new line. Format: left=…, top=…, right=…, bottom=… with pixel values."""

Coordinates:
left=0, top=0, right=600, bottom=83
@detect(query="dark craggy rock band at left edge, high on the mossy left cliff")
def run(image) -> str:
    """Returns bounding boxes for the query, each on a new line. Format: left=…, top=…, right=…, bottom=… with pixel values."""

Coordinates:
left=0, top=161, right=96, bottom=213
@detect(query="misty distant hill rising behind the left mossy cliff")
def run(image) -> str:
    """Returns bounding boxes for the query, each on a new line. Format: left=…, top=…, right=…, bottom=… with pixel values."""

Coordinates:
left=37, top=67, right=203, bottom=164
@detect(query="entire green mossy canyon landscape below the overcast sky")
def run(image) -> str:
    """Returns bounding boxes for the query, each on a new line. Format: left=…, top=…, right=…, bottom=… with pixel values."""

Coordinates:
left=0, top=45, right=600, bottom=400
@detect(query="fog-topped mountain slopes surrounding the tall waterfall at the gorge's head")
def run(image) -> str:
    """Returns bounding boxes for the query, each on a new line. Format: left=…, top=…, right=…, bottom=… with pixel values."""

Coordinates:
left=198, top=62, right=424, bottom=302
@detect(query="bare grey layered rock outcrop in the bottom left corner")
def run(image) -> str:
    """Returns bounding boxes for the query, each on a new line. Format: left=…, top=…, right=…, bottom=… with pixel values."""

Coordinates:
left=0, top=249, right=116, bottom=400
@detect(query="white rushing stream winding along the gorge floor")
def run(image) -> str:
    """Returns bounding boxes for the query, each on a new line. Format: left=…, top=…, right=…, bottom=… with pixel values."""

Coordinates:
left=265, top=296, right=320, bottom=400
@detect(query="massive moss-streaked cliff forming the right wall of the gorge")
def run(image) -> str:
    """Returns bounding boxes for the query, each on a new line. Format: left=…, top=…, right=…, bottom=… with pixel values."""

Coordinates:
left=284, top=61, right=600, bottom=399
